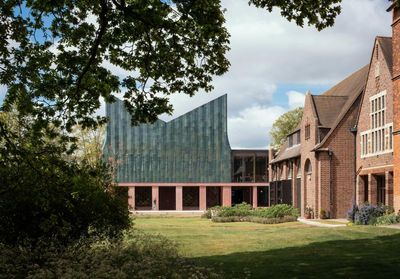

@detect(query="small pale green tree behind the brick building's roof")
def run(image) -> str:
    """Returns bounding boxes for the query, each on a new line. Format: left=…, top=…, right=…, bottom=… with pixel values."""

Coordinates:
left=270, top=108, right=303, bottom=149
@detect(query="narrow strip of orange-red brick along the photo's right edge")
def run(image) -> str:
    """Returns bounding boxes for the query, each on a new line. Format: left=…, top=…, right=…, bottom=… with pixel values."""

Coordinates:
left=388, top=0, right=400, bottom=211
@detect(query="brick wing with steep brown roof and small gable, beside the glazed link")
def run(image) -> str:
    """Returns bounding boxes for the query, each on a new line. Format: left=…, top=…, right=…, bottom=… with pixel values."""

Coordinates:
left=270, top=67, right=368, bottom=218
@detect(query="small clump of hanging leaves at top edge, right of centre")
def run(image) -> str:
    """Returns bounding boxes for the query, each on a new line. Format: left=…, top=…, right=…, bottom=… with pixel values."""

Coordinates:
left=249, top=0, right=342, bottom=30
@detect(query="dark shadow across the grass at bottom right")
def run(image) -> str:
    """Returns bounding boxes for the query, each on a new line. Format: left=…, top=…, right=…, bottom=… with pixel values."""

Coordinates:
left=195, top=233, right=400, bottom=279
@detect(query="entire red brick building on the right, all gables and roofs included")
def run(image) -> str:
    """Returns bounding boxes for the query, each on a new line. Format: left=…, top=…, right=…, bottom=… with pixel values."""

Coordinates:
left=270, top=0, right=400, bottom=218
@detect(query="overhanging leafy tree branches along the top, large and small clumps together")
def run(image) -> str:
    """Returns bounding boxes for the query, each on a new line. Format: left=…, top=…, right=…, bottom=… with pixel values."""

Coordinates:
left=0, top=0, right=340, bottom=131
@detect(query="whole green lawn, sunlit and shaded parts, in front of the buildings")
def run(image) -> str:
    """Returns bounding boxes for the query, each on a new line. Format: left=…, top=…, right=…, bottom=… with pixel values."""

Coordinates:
left=135, top=217, right=400, bottom=279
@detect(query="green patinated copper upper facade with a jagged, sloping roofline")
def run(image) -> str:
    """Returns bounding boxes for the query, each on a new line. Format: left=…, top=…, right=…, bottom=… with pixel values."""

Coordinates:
left=104, top=95, right=231, bottom=183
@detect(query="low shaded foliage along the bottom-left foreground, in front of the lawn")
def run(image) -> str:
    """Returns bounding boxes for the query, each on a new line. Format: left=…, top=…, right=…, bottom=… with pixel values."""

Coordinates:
left=0, top=230, right=220, bottom=279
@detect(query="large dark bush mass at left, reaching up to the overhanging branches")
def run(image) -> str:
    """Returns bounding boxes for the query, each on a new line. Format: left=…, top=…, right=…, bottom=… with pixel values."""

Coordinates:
left=0, top=113, right=130, bottom=244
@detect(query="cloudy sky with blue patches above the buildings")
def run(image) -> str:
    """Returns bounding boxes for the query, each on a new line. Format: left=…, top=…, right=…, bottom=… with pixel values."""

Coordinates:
left=0, top=0, right=391, bottom=148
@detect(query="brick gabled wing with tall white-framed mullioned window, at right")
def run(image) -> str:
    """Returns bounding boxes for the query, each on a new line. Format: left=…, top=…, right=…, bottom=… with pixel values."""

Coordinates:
left=356, top=37, right=393, bottom=206
